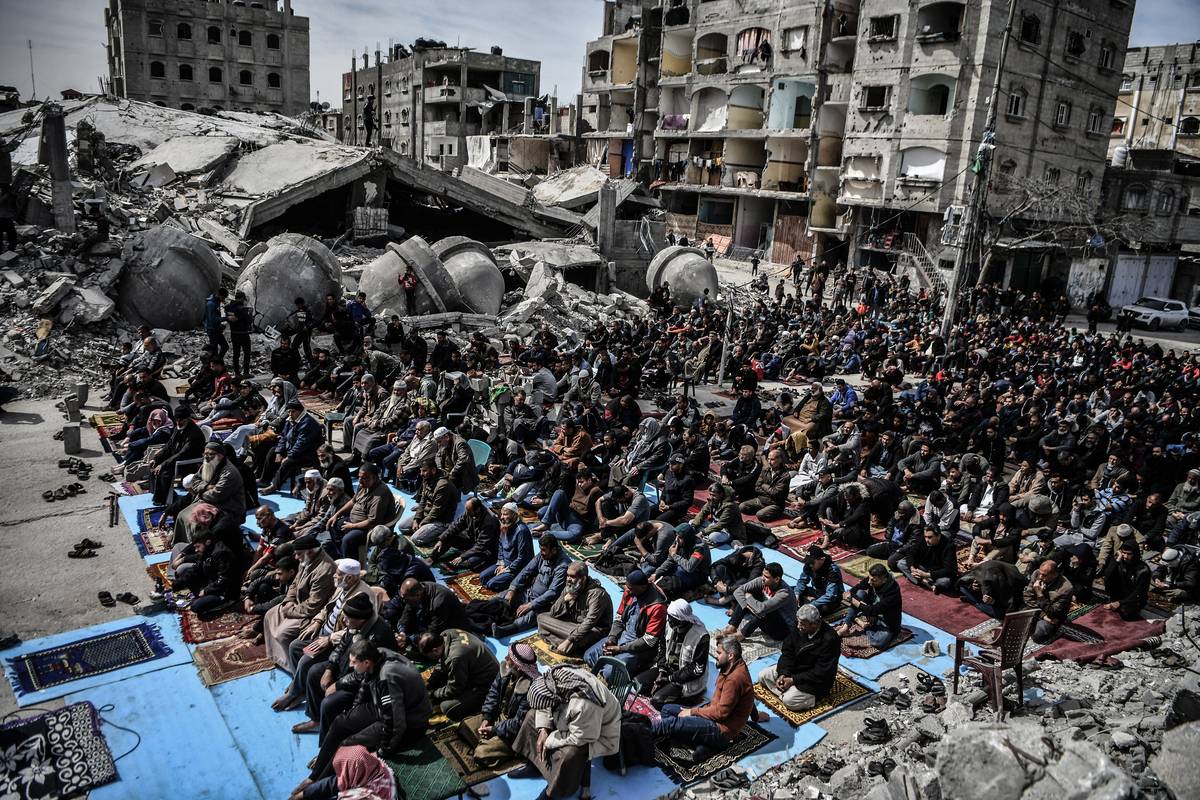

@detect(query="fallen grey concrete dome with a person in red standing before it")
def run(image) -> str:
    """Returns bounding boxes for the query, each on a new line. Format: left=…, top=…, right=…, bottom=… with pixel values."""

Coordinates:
left=359, top=236, right=463, bottom=317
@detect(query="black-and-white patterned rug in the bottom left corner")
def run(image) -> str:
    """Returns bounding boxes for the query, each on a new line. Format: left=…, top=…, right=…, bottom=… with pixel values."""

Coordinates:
left=0, top=703, right=116, bottom=800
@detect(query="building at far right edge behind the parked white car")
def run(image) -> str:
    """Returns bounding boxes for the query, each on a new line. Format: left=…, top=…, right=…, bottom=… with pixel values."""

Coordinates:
left=1099, top=42, right=1200, bottom=306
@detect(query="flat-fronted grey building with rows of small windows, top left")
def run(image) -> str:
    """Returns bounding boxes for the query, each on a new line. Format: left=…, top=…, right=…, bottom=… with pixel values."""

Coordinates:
left=104, top=0, right=311, bottom=116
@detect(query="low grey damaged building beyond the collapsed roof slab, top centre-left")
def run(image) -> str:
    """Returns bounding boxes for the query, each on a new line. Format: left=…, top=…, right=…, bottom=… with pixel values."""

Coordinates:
left=342, top=44, right=541, bottom=170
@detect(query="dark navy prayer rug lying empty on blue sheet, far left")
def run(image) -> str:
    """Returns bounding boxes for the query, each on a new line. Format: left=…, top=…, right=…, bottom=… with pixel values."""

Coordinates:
left=7, top=622, right=172, bottom=697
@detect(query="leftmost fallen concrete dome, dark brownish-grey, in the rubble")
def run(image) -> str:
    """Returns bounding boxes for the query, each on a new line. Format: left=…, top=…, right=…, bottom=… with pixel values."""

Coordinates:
left=116, top=227, right=221, bottom=331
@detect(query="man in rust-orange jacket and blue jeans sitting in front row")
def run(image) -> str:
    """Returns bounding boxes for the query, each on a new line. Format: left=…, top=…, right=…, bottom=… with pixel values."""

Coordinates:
left=650, top=638, right=754, bottom=763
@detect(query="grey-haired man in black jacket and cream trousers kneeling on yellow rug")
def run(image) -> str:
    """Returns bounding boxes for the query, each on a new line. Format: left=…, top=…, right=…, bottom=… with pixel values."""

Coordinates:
left=758, top=603, right=841, bottom=711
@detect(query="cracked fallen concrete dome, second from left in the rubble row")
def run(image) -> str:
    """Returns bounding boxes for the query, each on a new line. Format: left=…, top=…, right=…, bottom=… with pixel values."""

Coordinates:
left=238, top=234, right=342, bottom=327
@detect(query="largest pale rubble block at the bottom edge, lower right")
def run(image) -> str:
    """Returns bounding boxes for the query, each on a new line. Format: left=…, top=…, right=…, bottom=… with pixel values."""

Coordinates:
left=937, top=724, right=1026, bottom=800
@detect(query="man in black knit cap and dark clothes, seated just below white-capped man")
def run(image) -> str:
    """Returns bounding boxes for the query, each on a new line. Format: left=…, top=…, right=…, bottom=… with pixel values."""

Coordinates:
left=292, top=593, right=396, bottom=733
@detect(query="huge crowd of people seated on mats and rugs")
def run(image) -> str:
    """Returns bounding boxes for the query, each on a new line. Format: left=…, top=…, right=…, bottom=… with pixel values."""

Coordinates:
left=100, top=257, right=1200, bottom=799
